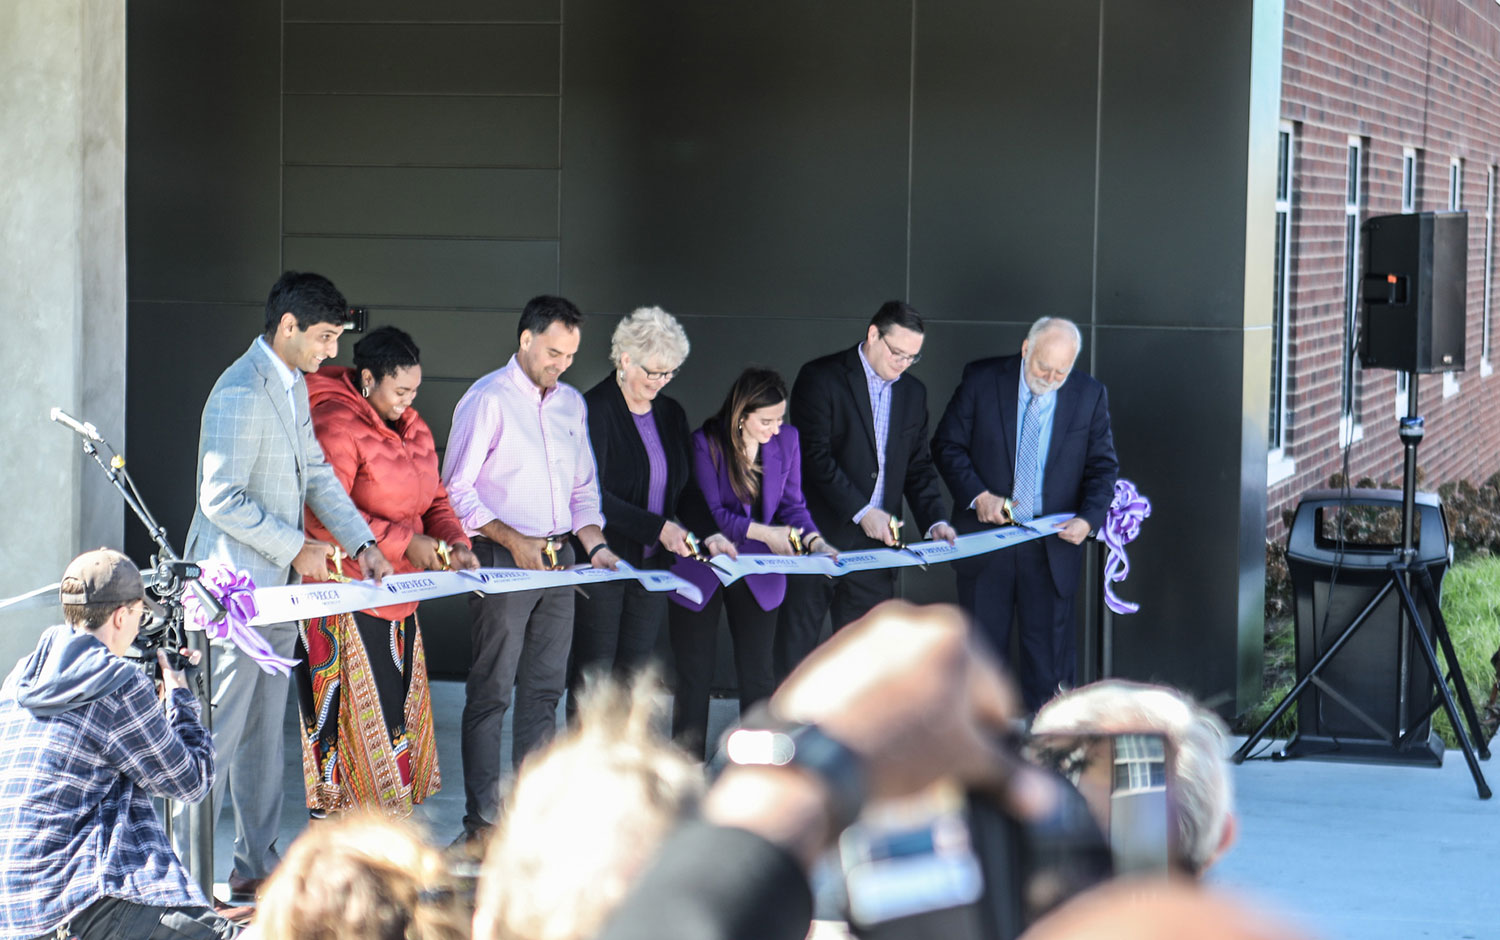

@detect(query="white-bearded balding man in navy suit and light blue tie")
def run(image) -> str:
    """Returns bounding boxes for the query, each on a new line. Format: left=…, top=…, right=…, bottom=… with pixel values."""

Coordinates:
left=933, top=318, right=1119, bottom=711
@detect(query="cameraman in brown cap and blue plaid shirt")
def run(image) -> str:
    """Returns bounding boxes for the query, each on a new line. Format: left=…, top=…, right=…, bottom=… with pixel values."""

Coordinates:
left=0, top=549, right=240, bottom=940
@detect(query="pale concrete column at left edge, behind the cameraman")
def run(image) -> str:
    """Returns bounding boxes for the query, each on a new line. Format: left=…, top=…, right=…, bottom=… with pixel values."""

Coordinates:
left=0, top=0, right=126, bottom=670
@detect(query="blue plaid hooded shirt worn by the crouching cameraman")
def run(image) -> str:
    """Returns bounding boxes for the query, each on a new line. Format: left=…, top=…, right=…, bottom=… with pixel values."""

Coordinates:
left=0, top=659, right=213, bottom=940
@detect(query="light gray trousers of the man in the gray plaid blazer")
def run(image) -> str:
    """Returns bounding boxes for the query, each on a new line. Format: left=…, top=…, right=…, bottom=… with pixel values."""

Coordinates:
left=173, top=624, right=297, bottom=879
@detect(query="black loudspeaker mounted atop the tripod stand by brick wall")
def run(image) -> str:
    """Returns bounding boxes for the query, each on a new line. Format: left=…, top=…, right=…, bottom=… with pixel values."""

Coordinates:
left=1359, top=211, right=1469, bottom=373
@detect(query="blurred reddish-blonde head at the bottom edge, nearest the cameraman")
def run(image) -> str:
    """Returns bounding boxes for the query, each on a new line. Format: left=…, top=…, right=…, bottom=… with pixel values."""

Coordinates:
left=255, top=813, right=468, bottom=940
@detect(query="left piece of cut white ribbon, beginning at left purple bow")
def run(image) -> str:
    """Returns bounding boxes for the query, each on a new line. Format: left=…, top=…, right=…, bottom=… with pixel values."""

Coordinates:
left=249, top=562, right=704, bottom=627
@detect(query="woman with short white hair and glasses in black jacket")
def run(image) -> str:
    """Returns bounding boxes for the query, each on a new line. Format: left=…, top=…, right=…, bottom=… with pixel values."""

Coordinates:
left=567, top=307, right=723, bottom=715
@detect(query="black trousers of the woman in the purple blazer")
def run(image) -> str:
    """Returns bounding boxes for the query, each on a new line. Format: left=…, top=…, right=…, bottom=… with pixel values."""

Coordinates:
left=668, top=580, right=776, bottom=760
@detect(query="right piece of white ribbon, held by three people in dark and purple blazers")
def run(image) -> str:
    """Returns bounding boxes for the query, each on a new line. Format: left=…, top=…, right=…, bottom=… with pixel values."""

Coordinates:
left=696, top=513, right=1073, bottom=585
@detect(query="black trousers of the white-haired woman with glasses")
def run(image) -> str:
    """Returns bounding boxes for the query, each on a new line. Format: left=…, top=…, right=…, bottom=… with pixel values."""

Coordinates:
left=567, top=580, right=668, bottom=717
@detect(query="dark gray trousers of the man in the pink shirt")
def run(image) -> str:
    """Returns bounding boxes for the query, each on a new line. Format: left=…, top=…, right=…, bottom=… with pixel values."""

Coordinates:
left=462, top=538, right=573, bottom=831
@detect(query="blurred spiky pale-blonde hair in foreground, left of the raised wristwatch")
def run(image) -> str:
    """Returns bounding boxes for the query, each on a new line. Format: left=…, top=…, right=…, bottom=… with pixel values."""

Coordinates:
left=474, top=672, right=704, bottom=940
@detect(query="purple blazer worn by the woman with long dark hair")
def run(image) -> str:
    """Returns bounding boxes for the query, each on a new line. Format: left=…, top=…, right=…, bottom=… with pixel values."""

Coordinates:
left=671, top=424, right=818, bottom=610
